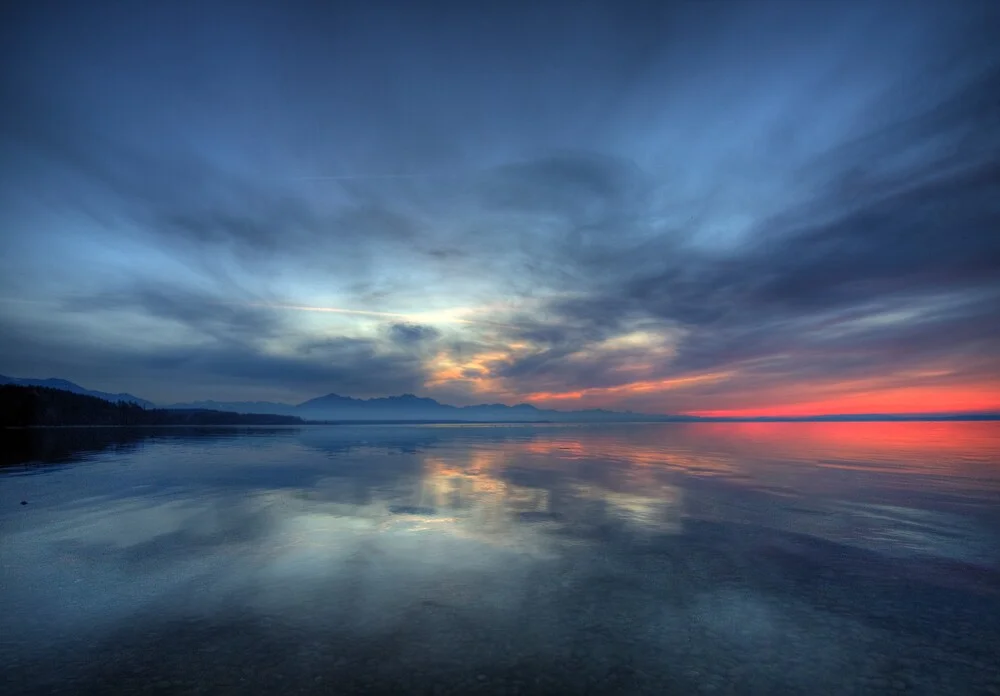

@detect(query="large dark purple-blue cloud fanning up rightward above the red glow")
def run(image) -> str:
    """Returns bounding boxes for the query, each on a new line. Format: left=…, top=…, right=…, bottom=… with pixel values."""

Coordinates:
left=474, top=57, right=1000, bottom=400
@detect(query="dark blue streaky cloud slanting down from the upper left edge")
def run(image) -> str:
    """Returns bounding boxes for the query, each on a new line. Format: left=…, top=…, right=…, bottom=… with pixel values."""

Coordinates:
left=0, top=85, right=419, bottom=272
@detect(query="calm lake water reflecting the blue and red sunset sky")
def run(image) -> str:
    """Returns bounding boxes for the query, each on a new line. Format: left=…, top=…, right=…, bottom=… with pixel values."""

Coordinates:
left=0, top=423, right=1000, bottom=696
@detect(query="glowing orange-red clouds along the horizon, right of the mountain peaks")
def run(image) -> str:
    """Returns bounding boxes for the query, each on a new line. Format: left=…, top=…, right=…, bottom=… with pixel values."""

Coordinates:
left=408, top=318, right=1000, bottom=417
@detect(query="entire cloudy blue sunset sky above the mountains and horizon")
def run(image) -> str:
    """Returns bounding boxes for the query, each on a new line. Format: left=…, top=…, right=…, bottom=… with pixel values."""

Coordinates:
left=0, top=0, right=1000, bottom=415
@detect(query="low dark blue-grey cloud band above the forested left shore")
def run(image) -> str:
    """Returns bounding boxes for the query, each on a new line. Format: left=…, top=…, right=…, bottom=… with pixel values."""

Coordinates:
left=3, top=301, right=425, bottom=403
